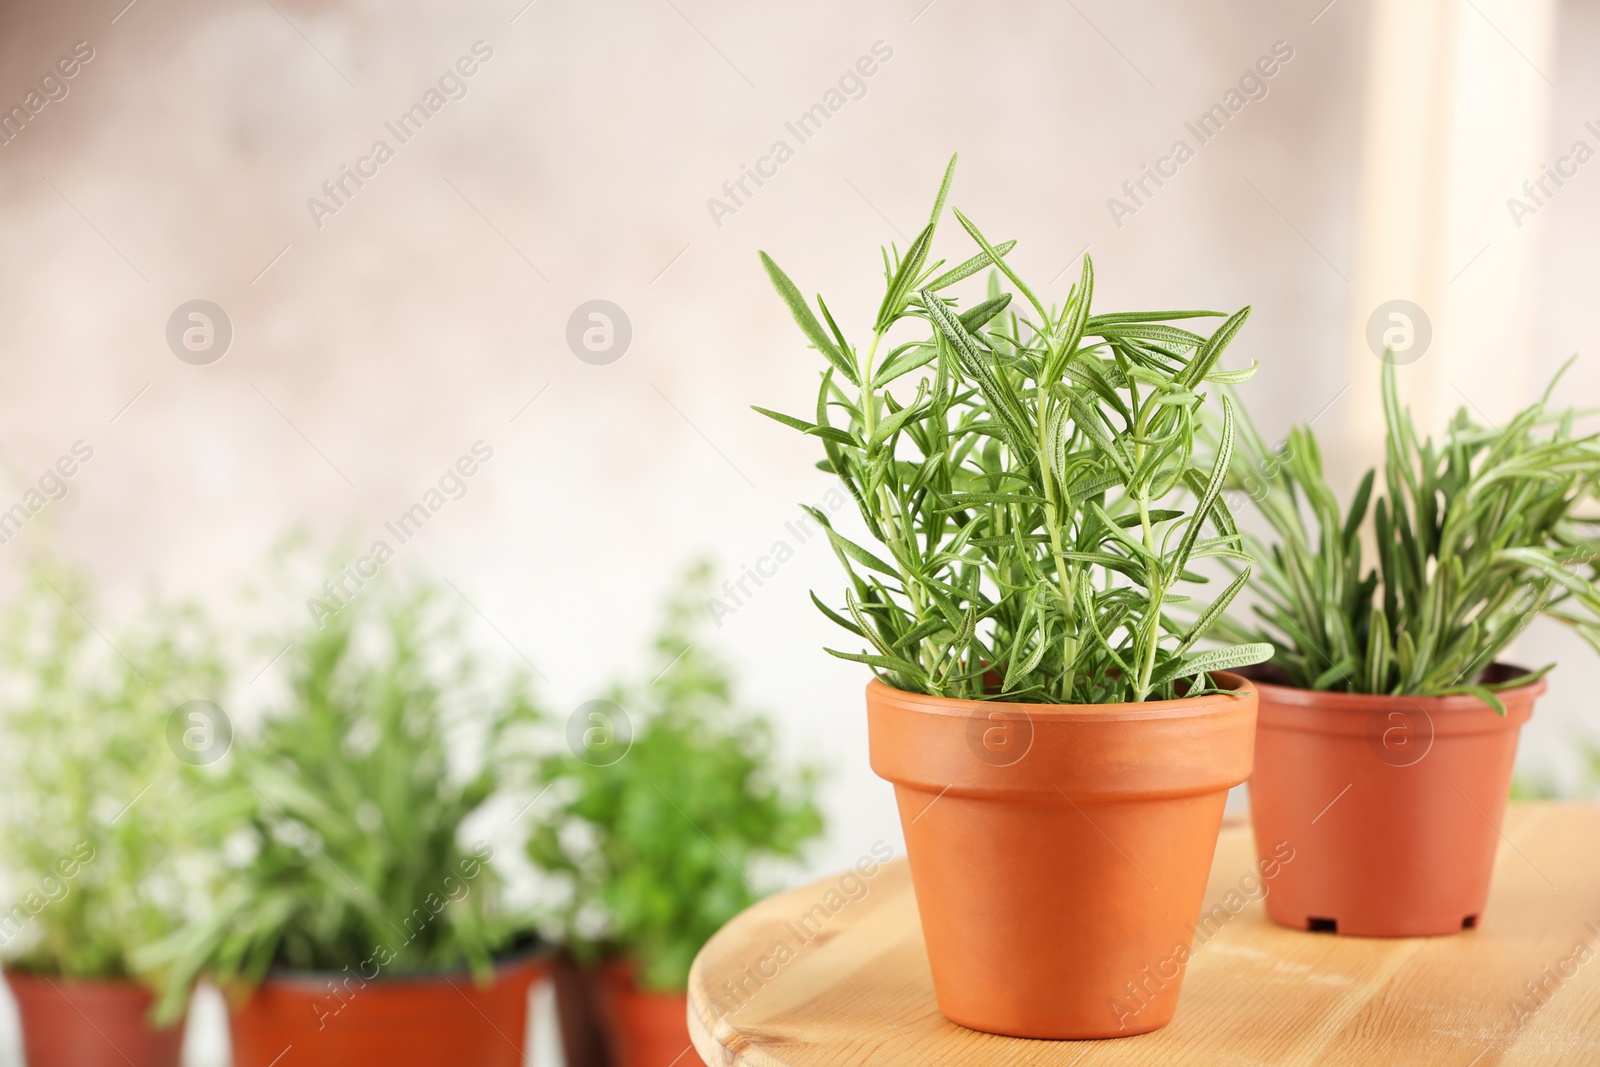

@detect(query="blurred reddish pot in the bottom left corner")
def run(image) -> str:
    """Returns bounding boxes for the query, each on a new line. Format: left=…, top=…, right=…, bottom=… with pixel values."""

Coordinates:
left=5, top=971, right=184, bottom=1067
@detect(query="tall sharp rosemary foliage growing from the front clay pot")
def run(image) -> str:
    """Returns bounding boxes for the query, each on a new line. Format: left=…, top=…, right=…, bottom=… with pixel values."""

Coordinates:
left=757, top=158, right=1272, bottom=704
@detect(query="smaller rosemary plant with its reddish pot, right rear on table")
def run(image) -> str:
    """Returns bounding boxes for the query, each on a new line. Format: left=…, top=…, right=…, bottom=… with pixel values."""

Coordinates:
left=1224, top=365, right=1600, bottom=936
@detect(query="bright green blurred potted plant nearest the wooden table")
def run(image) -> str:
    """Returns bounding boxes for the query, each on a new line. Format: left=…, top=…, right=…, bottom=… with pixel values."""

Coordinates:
left=528, top=563, right=822, bottom=1067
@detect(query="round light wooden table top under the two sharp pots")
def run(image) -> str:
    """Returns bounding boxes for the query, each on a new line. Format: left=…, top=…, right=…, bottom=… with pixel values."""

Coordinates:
left=690, top=803, right=1600, bottom=1067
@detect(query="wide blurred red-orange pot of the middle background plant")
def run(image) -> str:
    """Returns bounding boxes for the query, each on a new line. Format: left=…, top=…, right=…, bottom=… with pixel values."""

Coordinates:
left=230, top=955, right=549, bottom=1067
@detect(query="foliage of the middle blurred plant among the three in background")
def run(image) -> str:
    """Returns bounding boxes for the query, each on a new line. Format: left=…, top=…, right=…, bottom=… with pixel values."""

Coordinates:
left=140, top=579, right=538, bottom=1016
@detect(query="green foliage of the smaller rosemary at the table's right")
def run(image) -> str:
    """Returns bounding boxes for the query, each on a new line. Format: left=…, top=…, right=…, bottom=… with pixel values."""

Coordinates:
left=1218, top=365, right=1600, bottom=713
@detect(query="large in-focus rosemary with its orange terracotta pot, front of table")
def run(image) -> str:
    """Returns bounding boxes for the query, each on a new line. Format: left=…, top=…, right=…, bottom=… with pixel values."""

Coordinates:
left=758, top=160, right=1272, bottom=1038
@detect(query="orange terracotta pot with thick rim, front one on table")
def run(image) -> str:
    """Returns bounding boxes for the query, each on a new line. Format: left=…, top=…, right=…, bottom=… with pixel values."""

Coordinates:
left=867, top=673, right=1256, bottom=1038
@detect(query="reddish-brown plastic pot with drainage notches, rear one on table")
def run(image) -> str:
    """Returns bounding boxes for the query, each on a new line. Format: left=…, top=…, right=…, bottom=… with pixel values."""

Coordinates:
left=1250, top=665, right=1546, bottom=937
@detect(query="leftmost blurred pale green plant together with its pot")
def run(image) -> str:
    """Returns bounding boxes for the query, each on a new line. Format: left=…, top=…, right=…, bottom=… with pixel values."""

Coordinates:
left=0, top=563, right=226, bottom=1067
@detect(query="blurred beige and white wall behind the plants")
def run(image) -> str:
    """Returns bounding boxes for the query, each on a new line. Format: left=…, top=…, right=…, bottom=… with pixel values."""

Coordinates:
left=0, top=0, right=1600, bottom=908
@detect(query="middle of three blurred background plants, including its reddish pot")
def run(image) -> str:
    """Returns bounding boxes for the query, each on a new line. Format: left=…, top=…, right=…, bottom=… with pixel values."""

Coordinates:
left=149, top=582, right=544, bottom=1067
